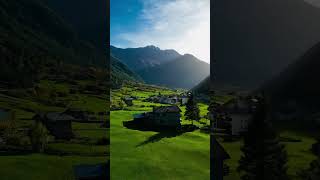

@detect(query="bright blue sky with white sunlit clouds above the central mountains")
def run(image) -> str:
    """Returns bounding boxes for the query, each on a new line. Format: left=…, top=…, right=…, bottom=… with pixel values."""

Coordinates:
left=110, top=0, right=210, bottom=63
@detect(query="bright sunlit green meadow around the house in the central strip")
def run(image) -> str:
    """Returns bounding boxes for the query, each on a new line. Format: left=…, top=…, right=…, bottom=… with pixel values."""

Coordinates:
left=110, top=83, right=210, bottom=180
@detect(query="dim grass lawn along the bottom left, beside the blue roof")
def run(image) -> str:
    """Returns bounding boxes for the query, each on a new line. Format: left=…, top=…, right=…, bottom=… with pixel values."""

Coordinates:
left=0, top=154, right=107, bottom=180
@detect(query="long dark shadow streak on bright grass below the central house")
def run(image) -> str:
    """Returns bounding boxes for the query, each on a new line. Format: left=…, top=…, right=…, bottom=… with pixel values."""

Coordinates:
left=136, top=124, right=199, bottom=147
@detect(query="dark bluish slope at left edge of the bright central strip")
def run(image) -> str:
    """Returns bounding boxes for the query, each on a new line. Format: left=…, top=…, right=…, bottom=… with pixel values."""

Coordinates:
left=110, top=55, right=143, bottom=87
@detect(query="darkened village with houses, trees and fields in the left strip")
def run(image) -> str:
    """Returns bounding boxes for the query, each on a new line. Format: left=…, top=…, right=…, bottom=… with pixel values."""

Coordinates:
left=0, top=78, right=109, bottom=179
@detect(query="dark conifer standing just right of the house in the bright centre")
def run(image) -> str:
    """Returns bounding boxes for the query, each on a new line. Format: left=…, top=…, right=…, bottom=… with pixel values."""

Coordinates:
left=184, top=93, right=200, bottom=125
